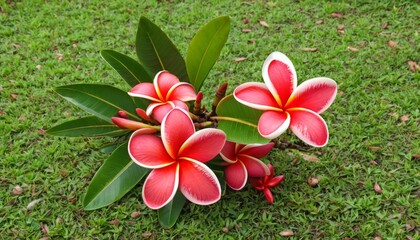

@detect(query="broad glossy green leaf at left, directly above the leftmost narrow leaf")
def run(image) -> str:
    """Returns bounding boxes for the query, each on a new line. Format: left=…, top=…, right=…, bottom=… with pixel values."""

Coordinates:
left=55, top=84, right=140, bottom=122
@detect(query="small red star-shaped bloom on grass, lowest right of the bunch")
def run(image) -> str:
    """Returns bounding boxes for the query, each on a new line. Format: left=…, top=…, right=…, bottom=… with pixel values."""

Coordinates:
left=251, top=164, right=284, bottom=204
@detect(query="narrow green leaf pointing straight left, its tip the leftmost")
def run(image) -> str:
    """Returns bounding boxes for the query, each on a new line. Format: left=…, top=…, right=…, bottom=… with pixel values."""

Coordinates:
left=47, top=116, right=130, bottom=137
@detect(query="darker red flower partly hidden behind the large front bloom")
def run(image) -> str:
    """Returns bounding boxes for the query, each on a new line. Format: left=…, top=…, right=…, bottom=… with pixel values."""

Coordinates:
left=220, top=141, right=274, bottom=190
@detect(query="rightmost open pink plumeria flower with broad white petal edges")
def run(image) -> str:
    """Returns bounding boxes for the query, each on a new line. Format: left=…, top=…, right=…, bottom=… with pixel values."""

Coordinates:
left=233, top=52, right=337, bottom=147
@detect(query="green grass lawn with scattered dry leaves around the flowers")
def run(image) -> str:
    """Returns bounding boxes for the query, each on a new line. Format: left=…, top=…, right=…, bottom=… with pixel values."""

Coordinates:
left=0, top=0, right=420, bottom=239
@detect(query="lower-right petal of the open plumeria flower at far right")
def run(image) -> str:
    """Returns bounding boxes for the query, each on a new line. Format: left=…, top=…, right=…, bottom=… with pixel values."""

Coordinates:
left=289, top=108, right=328, bottom=147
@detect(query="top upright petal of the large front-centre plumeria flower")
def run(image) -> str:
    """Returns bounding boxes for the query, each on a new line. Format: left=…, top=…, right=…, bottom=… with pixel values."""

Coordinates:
left=161, top=108, right=195, bottom=159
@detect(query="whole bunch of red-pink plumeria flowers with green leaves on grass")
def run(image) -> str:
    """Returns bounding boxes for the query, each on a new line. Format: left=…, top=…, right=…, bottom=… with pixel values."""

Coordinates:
left=48, top=17, right=337, bottom=227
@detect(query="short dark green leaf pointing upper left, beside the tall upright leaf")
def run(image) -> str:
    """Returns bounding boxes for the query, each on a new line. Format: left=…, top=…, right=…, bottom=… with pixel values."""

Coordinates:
left=101, top=50, right=153, bottom=87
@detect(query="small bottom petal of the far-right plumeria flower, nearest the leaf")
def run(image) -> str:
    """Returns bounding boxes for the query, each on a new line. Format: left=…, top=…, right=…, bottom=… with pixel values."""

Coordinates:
left=258, top=111, right=290, bottom=139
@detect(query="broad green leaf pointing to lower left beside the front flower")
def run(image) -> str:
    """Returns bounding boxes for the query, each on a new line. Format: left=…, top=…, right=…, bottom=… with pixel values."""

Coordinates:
left=83, top=143, right=149, bottom=210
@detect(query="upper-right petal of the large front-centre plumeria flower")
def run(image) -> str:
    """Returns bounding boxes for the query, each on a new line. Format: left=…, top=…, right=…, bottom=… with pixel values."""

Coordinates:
left=178, top=128, right=226, bottom=163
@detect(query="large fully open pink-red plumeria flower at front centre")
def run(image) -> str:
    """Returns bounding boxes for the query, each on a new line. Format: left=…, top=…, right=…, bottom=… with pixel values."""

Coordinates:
left=128, top=108, right=226, bottom=209
